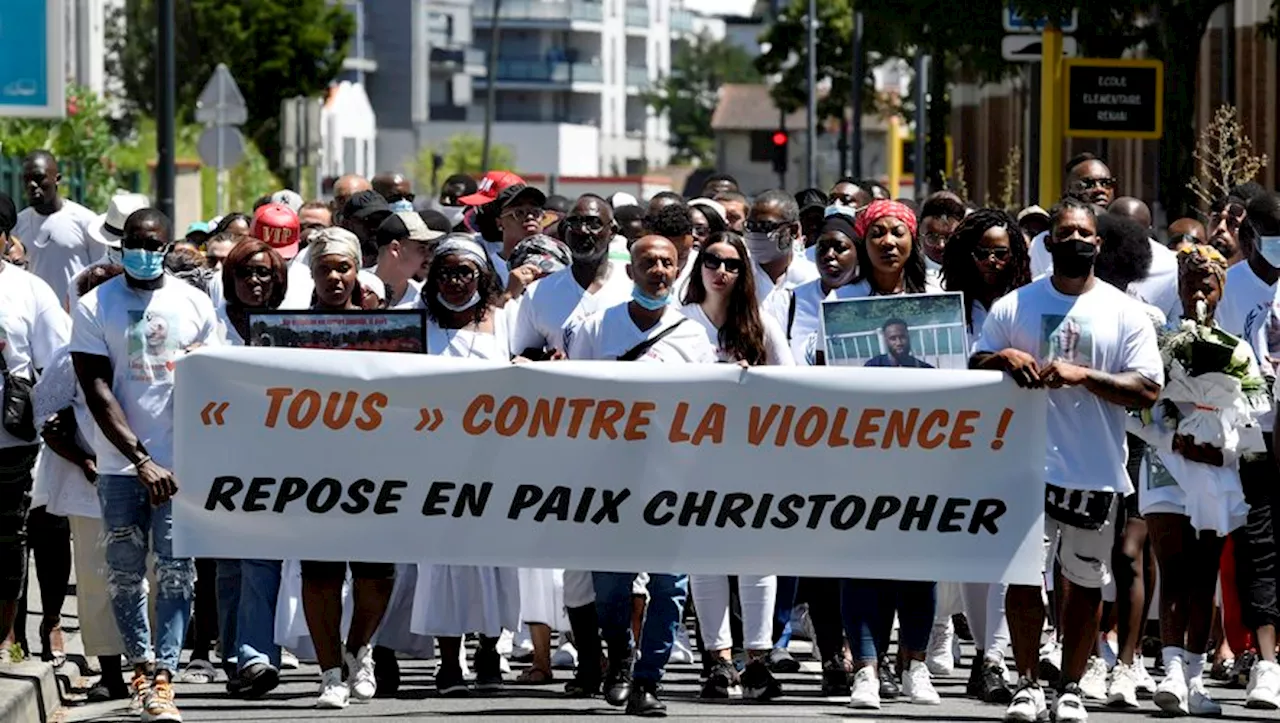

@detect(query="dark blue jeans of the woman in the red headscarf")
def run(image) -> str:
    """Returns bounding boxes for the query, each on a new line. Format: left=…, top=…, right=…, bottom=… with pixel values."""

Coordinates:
left=841, top=580, right=938, bottom=662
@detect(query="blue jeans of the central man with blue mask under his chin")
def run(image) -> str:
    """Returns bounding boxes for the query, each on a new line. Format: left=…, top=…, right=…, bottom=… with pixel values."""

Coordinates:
left=591, top=572, right=689, bottom=683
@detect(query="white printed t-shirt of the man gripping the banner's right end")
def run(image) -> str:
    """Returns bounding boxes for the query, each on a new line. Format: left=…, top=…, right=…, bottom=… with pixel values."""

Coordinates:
left=978, top=276, right=1165, bottom=494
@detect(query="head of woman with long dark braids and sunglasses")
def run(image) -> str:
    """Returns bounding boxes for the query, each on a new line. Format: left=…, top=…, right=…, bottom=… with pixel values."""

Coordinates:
left=942, top=209, right=1032, bottom=340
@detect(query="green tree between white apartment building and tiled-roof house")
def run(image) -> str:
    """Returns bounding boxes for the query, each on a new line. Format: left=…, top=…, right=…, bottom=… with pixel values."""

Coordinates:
left=644, top=33, right=760, bottom=165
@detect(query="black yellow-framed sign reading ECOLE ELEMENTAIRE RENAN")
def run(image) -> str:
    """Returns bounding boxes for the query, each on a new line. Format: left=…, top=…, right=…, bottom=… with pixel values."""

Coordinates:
left=1062, top=58, right=1165, bottom=139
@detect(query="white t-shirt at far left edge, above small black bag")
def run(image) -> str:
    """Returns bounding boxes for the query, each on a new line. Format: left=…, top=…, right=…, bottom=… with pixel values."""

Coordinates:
left=0, top=261, right=72, bottom=448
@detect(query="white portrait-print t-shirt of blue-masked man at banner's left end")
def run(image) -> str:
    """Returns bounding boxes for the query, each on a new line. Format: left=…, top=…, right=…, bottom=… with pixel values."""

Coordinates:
left=70, top=274, right=221, bottom=475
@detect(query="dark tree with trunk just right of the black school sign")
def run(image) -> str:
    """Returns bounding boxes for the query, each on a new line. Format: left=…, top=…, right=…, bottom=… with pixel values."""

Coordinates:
left=1011, top=0, right=1280, bottom=219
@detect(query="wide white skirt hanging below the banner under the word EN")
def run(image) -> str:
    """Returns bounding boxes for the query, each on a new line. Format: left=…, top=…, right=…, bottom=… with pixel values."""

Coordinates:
left=410, top=563, right=520, bottom=637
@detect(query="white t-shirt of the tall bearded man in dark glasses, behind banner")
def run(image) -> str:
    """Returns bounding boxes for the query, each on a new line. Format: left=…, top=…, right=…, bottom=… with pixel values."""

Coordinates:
left=511, top=261, right=634, bottom=354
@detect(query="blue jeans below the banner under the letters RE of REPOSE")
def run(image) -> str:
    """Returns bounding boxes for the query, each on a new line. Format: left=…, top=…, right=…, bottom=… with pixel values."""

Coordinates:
left=218, top=559, right=280, bottom=671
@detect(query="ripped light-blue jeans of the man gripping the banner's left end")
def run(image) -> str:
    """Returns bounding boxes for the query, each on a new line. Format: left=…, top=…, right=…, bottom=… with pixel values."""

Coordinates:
left=97, top=475, right=196, bottom=673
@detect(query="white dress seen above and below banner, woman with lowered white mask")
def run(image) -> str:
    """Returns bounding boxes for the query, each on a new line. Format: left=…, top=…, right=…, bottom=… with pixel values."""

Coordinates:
left=410, top=311, right=520, bottom=637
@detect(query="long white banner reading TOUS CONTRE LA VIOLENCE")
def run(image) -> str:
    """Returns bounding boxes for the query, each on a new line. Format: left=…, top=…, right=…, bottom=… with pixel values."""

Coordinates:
left=174, top=348, right=1044, bottom=585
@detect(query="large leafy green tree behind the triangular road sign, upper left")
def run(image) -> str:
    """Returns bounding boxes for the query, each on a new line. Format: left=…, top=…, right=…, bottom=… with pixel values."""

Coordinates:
left=106, top=0, right=355, bottom=179
